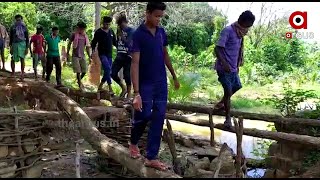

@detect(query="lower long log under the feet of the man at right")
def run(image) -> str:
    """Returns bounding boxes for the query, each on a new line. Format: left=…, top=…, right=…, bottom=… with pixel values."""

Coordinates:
left=166, top=114, right=320, bottom=148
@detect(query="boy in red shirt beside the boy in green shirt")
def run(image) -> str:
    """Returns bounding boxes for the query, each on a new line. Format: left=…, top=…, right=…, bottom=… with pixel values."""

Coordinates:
left=29, top=27, right=46, bottom=80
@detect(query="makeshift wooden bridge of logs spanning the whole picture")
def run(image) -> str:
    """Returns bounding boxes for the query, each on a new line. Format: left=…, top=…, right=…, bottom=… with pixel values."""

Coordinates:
left=0, top=69, right=320, bottom=178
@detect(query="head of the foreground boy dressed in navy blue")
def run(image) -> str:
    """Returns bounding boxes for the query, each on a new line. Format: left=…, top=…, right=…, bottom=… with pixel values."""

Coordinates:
left=146, top=2, right=166, bottom=26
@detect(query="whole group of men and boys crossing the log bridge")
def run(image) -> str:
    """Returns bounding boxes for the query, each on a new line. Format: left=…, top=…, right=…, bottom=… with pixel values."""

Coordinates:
left=0, top=2, right=255, bottom=170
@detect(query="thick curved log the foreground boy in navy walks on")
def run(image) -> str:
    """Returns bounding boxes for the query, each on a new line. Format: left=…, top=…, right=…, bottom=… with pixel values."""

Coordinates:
left=35, top=85, right=181, bottom=178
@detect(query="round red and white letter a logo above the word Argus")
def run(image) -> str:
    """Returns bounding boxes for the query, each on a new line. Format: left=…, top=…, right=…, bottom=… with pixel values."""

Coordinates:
left=289, top=11, right=308, bottom=29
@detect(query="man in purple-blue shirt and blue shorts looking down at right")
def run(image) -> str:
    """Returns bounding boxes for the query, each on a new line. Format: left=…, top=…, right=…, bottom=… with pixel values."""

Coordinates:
left=215, top=11, right=255, bottom=128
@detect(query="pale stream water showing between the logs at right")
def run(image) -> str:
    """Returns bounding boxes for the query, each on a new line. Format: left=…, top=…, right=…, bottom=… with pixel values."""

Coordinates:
left=170, top=114, right=273, bottom=178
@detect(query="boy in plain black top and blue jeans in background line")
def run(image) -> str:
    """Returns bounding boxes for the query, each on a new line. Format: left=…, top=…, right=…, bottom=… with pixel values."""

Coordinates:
left=91, top=16, right=117, bottom=95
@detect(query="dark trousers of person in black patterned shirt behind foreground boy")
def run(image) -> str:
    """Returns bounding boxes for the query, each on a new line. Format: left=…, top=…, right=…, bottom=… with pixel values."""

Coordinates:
left=111, top=53, right=131, bottom=86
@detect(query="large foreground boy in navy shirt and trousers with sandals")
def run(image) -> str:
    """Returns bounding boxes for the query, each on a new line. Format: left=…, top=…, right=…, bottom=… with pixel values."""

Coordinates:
left=129, top=2, right=180, bottom=170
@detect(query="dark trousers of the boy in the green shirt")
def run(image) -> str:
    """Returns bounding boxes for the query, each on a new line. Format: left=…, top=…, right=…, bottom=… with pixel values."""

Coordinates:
left=46, top=56, right=61, bottom=85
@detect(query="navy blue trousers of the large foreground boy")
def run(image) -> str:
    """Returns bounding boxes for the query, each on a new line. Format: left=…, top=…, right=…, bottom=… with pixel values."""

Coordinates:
left=131, top=82, right=168, bottom=160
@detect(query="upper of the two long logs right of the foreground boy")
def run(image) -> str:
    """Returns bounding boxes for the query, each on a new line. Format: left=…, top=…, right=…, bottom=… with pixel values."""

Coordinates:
left=167, top=103, right=320, bottom=126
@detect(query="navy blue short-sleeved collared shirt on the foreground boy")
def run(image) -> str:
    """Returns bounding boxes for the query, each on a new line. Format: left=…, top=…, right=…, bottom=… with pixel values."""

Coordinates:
left=130, top=24, right=168, bottom=84
